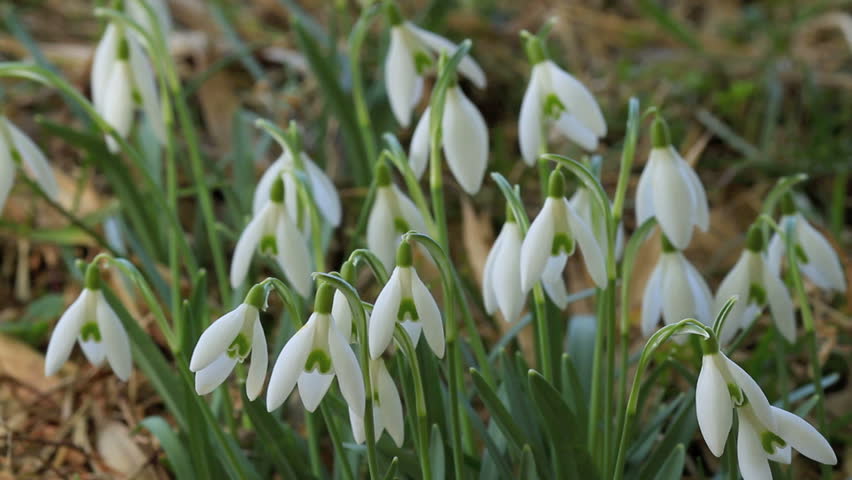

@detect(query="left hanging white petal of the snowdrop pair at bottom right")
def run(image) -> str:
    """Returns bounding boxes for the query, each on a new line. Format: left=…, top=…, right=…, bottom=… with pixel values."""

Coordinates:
left=695, top=355, right=734, bottom=457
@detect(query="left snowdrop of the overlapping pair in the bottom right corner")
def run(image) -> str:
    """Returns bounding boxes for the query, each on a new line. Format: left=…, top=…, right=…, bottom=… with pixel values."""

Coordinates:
left=695, top=341, right=775, bottom=457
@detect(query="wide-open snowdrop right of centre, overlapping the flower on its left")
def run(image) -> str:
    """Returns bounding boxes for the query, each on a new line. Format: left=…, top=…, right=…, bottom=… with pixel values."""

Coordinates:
left=521, top=170, right=607, bottom=308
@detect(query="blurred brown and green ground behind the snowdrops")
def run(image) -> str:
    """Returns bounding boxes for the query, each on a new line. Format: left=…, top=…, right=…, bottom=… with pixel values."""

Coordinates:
left=0, top=0, right=852, bottom=479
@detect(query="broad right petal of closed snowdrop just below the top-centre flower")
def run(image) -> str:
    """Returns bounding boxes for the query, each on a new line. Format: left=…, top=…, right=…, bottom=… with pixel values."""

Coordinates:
left=441, top=86, right=488, bottom=195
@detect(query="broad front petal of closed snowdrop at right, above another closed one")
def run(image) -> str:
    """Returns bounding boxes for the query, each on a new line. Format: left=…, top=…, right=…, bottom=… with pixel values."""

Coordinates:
left=652, top=151, right=695, bottom=250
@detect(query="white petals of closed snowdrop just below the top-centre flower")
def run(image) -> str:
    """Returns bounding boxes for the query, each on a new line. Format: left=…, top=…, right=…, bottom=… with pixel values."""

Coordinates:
left=408, top=85, right=488, bottom=195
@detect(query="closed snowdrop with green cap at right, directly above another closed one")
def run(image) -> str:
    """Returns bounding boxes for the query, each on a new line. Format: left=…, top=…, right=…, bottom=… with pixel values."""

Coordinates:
left=636, top=117, right=710, bottom=250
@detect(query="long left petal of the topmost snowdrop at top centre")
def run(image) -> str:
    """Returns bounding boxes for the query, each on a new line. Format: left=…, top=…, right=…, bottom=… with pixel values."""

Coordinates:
left=385, top=26, right=419, bottom=127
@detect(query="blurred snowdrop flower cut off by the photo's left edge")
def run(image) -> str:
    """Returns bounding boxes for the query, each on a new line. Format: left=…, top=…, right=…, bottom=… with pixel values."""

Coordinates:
left=0, top=115, right=59, bottom=212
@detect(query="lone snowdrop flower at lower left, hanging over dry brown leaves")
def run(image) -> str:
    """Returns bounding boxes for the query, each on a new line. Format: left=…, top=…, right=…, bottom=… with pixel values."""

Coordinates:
left=44, top=264, right=133, bottom=381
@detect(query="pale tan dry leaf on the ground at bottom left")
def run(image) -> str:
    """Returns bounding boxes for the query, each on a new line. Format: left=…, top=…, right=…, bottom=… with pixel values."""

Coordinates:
left=98, top=422, right=157, bottom=480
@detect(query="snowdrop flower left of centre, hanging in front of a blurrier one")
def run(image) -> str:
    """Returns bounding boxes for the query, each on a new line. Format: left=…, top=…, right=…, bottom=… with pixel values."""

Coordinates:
left=231, top=178, right=312, bottom=297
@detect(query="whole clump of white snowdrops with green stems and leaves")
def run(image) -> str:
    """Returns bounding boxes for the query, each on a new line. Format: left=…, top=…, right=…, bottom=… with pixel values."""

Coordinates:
left=0, top=0, right=845, bottom=480
